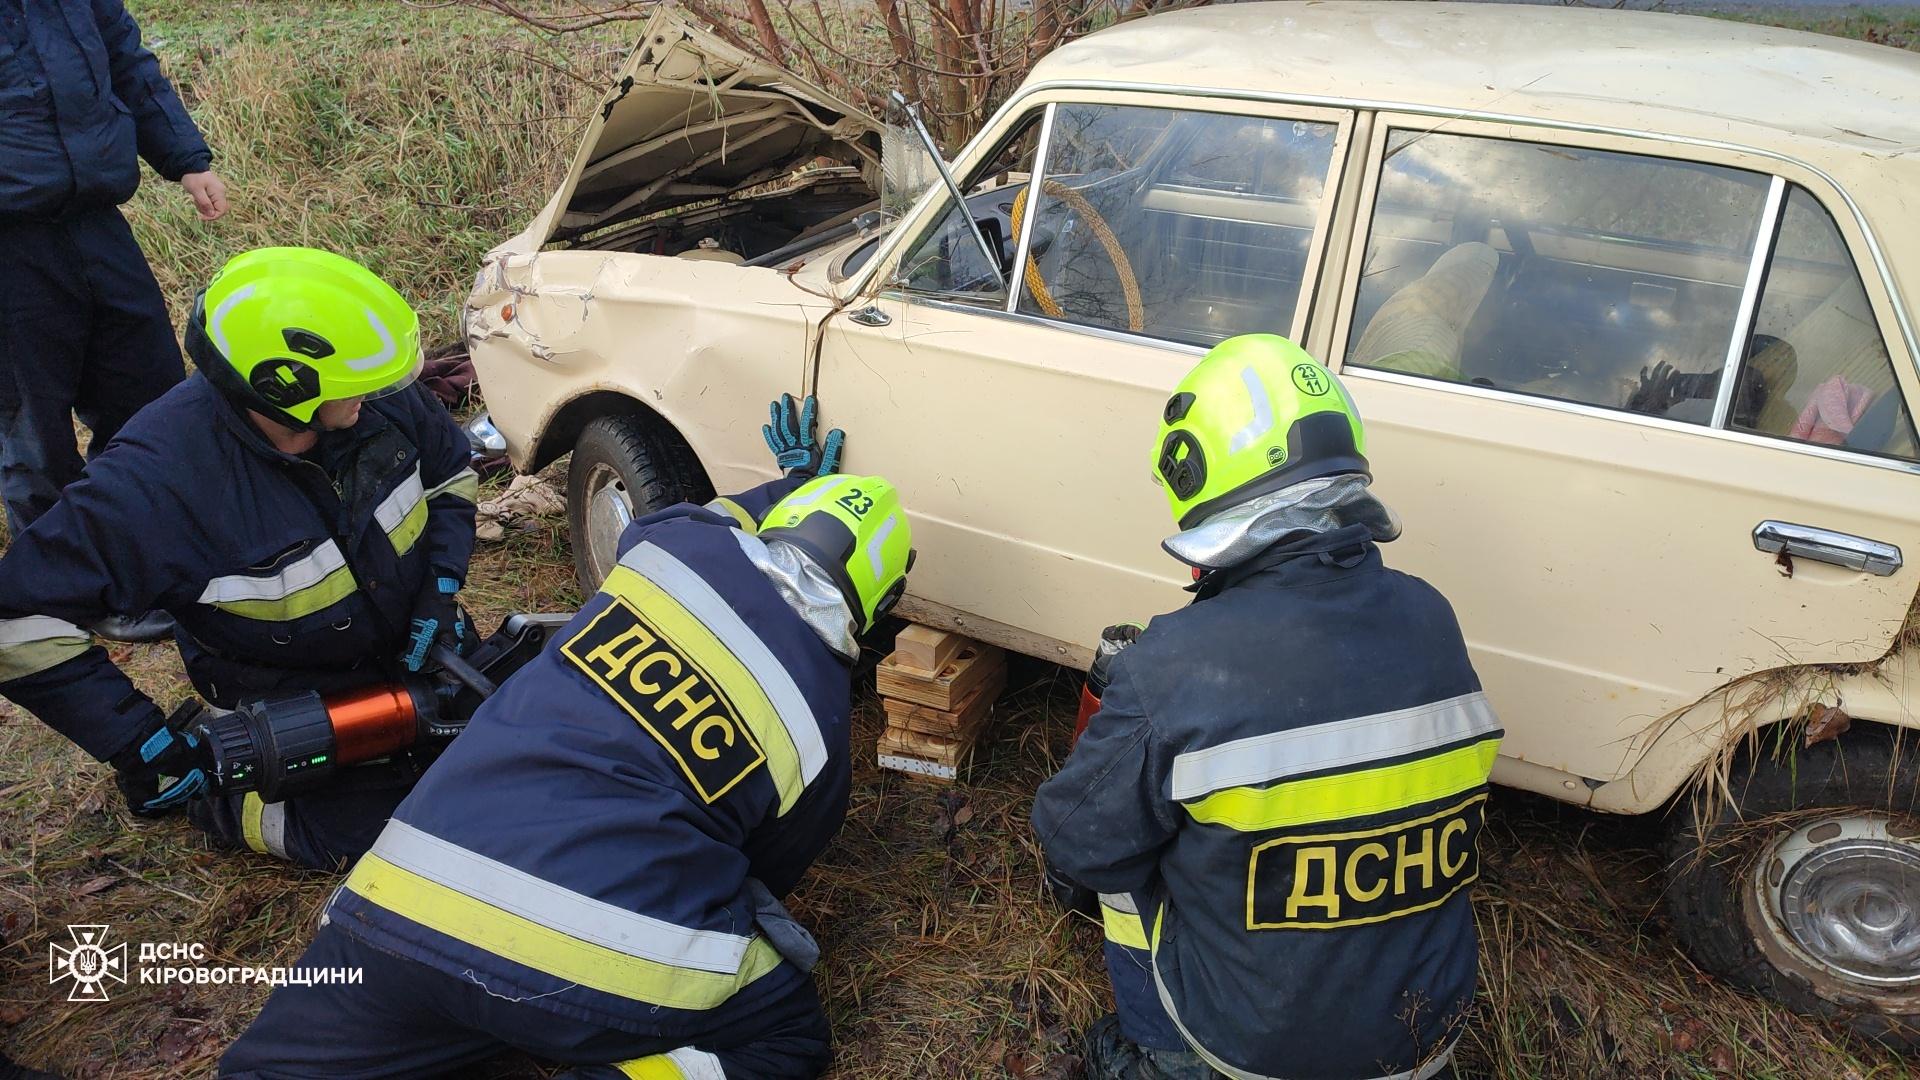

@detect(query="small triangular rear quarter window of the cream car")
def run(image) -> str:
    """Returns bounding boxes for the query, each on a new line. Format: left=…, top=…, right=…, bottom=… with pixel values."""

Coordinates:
left=1730, top=186, right=1916, bottom=461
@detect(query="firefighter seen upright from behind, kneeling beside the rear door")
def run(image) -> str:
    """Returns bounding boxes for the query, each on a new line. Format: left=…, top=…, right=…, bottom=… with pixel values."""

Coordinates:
left=1033, top=334, right=1501, bottom=1080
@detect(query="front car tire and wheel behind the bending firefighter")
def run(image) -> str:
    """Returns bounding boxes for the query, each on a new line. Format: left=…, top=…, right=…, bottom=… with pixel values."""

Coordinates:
left=566, top=413, right=712, bottom=592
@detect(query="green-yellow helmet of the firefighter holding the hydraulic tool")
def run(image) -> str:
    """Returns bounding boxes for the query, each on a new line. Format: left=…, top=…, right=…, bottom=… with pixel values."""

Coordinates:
left=186, top=248, right=420, bottom=430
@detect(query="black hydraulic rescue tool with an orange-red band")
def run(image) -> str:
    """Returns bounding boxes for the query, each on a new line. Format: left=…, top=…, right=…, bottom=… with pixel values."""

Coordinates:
left=169, top=615, right=572, bottom=803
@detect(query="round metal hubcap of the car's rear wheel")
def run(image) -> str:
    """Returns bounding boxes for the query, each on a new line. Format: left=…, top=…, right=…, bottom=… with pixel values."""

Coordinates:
left=1753, top=815, right=1920, bottom=990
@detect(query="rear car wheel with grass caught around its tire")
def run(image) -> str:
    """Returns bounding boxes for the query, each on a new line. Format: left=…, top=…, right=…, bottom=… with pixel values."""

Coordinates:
left=1667, top=724, right=1920, bottom=1047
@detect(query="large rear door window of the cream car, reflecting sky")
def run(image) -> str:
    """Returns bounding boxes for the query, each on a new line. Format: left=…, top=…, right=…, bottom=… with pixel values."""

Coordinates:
left=1346, top=131, right=1770, bottom=423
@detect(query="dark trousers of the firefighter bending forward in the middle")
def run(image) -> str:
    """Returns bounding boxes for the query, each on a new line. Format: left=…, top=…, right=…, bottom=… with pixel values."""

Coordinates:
left=221, top=924, right=829, bottom=1080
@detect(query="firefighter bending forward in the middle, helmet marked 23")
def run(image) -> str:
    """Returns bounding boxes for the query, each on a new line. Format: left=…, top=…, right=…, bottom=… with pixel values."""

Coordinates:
left=221, top=399, right=912, bottom=1080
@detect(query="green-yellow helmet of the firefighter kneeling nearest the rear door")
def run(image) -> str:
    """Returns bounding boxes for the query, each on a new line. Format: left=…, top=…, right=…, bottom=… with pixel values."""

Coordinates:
left=1154, top=334, right=1373, bottom=528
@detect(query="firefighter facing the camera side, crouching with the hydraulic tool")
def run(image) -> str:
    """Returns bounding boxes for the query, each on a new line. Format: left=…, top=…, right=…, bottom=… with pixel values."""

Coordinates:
left=0, top=248, right=478, bottom=869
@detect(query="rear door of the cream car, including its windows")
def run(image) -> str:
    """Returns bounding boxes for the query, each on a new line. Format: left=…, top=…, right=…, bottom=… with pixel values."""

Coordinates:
left=1332, top=115, right=1920, bottom=798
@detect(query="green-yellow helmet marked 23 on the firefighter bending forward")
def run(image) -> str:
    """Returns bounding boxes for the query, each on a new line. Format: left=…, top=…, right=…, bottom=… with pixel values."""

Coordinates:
left=760, top=475, right=914, bottom=634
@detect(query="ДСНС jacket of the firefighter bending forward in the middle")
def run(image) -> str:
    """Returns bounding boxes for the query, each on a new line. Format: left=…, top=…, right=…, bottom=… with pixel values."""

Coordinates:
left=326, top=479, right=851, bottom=1043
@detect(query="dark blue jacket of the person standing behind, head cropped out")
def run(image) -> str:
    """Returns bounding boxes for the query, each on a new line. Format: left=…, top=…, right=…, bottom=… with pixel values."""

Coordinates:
left=0, top=0, right=213, bottom=219
